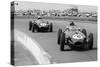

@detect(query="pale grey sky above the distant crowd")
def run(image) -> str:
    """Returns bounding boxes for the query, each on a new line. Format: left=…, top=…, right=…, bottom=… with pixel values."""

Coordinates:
left=15, top=1, right=97, bottom=12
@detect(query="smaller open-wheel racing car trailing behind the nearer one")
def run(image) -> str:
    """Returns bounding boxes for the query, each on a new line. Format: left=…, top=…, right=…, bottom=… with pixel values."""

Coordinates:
left=29, top=18, right=53, bottom=32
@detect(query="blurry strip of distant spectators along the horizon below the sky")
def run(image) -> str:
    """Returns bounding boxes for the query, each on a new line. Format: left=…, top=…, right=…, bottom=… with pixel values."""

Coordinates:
left=14, top=8, right=97, bottom=17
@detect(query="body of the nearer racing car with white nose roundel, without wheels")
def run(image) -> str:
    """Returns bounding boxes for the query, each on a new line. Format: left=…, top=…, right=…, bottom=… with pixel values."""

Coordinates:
left=64, top=26, right=86, bottom=45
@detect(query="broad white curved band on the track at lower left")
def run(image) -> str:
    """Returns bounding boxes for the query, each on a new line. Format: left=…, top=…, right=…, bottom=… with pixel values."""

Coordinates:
left=14, top=30, right=51, bottom=64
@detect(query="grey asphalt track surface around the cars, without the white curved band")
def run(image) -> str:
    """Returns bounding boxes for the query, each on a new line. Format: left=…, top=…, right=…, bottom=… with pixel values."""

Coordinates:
left=14, top=18, right=97, bottom=65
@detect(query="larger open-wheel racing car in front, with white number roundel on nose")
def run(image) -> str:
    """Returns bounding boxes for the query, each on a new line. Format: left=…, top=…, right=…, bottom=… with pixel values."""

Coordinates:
left=57, top=22, right=93, bottom=51
